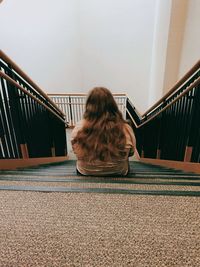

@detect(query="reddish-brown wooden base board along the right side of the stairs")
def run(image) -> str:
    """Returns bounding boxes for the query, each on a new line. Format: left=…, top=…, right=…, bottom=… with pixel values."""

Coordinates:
left=140, top=158, right=200, bottom=174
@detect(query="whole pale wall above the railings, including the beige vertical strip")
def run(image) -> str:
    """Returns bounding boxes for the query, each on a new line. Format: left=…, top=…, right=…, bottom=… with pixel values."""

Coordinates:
left=0, top=0, right=200, bottom=112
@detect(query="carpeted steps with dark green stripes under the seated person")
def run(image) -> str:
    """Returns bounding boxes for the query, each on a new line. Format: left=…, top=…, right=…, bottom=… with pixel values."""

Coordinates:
left=0, top=160, right=200, bottom=196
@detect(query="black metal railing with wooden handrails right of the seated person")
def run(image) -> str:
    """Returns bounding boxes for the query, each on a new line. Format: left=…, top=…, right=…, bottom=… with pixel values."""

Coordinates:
left=127, top=61, right=200, bottom=162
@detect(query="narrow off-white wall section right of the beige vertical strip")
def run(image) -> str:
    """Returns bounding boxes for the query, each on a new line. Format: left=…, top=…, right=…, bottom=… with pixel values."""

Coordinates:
left=179, top=0, right=200, bottom=78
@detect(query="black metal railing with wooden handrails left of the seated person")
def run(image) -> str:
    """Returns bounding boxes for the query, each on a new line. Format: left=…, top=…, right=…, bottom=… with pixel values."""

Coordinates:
left=0, top=51, right=67, bottom=159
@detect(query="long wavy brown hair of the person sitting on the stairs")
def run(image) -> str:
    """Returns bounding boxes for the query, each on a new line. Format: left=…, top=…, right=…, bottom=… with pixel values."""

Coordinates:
left=72, top=87, right=126, bottom=161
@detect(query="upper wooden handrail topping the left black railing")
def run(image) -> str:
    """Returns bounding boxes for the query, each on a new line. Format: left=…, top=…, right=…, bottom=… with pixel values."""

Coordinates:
left=0, top=50, right=64, bottom=115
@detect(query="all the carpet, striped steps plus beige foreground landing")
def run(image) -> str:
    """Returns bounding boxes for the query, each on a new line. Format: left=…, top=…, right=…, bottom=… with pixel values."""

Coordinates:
left=0, top=161, right=200, bottom=267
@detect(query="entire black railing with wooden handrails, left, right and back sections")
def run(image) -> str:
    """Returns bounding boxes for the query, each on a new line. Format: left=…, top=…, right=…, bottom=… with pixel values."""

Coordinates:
left=3, top=46, right=200, bottom=162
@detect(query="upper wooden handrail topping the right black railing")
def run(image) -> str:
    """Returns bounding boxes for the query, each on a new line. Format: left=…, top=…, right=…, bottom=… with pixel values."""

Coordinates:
left=142, top=60, right=200, bottom=117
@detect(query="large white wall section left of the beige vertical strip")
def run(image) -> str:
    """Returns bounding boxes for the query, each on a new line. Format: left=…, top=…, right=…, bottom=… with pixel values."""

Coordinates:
left=0, top=0, right=159, bottom=112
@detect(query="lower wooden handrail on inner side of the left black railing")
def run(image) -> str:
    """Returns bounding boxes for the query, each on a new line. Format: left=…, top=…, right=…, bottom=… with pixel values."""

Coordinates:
left=0, top=70, right=65, bottom=122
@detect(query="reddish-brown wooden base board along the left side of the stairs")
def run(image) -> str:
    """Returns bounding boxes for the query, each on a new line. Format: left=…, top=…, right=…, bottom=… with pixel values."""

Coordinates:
left=0, top=156, right=68, bottom=170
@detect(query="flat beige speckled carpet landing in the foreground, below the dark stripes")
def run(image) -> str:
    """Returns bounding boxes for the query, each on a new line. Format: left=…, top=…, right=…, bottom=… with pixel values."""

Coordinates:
left=0, top=191, right=200, bottom=267
